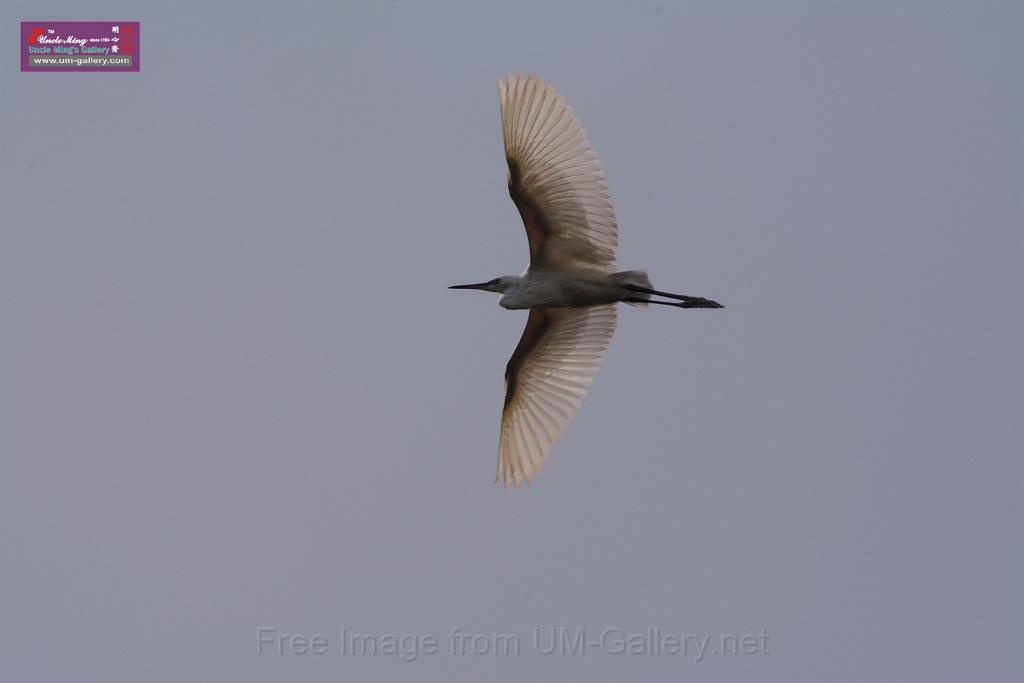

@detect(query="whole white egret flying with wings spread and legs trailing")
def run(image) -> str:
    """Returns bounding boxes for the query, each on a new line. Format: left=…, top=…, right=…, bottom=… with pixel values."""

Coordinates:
left=449, top=73, right=722, bottom=488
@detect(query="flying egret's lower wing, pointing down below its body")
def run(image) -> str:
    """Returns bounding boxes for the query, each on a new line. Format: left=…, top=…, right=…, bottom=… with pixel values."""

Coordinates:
left=496, top=304, right=615, bottom=488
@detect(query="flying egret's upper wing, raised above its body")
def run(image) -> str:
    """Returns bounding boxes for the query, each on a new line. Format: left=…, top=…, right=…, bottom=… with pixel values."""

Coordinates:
left=498, top=74, right=618, bottom=269
